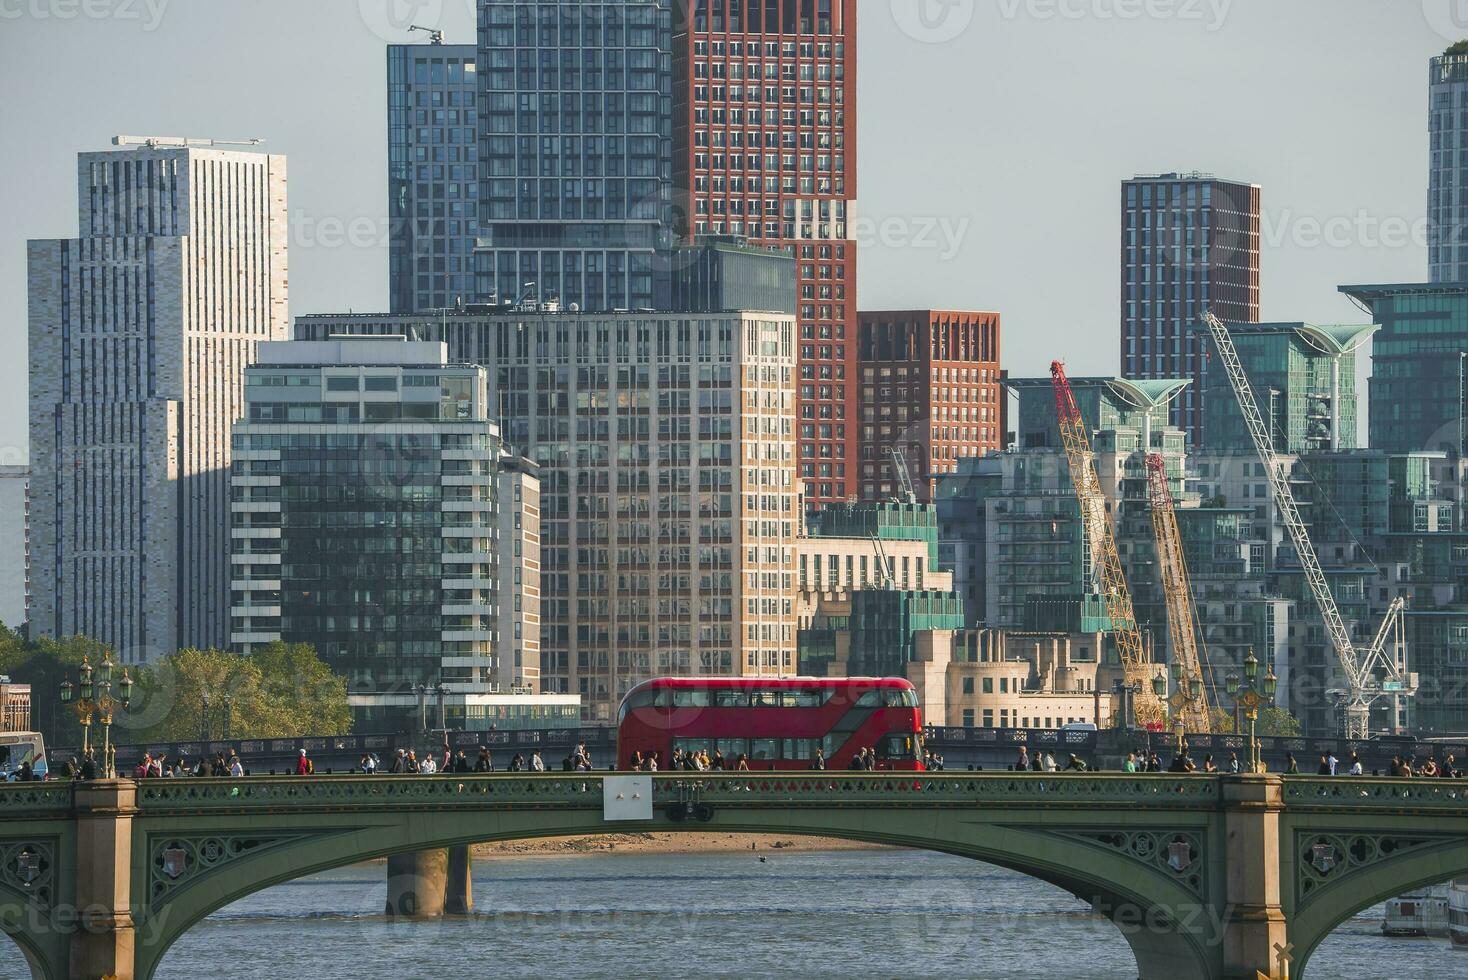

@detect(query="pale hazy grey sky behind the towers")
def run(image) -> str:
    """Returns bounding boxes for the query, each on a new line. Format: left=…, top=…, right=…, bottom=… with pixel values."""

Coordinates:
left=0, top=0, right=1450, bottom=462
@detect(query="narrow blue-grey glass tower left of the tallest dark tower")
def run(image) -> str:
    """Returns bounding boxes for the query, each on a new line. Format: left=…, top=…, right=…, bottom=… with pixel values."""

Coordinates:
left=388, top=44, right=479, bottom=312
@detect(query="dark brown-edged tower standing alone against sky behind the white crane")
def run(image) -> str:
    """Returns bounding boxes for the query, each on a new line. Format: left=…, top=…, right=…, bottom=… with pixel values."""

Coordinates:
left=1122, top=173, right=1260, bottom=446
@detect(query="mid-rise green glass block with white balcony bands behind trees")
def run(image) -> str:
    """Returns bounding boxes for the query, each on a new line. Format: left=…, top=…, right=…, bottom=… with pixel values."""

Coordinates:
left=230, top=337, right=580, bottom=732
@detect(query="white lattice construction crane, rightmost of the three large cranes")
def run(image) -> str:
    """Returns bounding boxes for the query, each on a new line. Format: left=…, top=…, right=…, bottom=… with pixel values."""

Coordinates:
left=1204, top=312, right=1417, bottom=739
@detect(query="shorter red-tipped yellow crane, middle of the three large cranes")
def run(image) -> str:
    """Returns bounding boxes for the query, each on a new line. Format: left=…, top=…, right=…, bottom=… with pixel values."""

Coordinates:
left=1147, top=453, right=1213, bottom=734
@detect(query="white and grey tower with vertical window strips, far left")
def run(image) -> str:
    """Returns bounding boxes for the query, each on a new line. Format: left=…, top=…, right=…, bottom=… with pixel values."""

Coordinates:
left=28, top=147, right=289, bottom=662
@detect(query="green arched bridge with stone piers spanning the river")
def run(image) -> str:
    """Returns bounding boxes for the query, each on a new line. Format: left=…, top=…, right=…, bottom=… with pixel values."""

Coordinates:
left=0, top=773, right=1468, bottom=980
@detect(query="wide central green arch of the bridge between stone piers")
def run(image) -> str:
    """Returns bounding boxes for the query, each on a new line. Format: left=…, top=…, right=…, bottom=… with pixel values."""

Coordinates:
left=134, top=778, right=1221, bottom=980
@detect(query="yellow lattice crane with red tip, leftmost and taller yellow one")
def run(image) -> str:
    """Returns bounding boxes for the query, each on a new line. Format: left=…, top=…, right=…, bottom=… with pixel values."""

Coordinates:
left=1050, top=361, right=1161, bottom=725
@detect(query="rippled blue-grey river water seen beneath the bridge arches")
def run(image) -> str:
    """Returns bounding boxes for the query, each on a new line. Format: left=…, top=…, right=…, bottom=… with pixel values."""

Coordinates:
left=0, top=848, right=1468, bottom=980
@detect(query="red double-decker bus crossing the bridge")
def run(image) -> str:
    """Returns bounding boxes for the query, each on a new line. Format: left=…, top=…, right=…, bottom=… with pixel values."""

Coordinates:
left=617, top=678, right=922, bottom=770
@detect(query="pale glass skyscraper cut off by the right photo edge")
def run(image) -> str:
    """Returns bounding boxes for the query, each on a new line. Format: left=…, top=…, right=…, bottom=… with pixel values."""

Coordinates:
left=1427, top=43, right=1468, bottom=283
